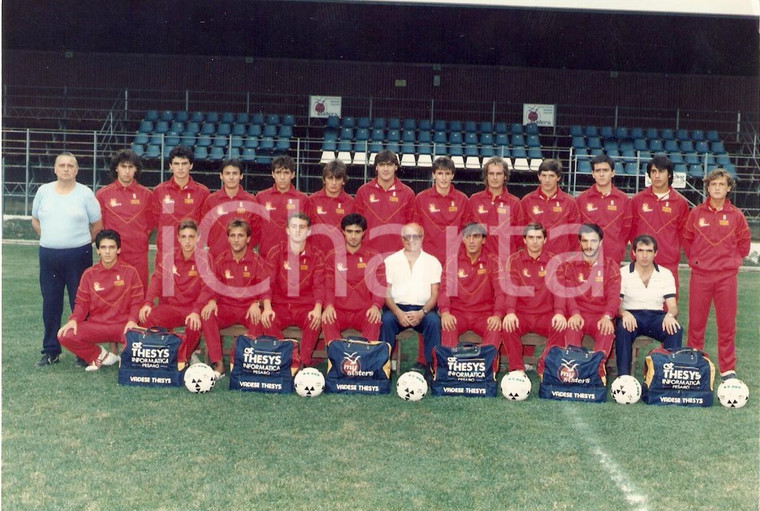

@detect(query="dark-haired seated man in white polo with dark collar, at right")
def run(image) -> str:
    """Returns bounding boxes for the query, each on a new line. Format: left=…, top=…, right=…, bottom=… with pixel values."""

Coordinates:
left=615, top=234, right=683, bottom=375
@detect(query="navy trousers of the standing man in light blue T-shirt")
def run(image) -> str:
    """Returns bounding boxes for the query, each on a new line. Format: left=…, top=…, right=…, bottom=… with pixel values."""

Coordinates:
left=39, top=245, right=92, bottom=356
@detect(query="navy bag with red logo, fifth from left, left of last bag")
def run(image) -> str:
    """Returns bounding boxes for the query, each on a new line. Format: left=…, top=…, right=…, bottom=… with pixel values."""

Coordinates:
left=538, top=346, right=607, bottom=403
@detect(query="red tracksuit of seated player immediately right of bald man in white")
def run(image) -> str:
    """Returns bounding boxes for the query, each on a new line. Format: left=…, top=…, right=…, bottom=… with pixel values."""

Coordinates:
left=438, top=248, right=504, bottom=349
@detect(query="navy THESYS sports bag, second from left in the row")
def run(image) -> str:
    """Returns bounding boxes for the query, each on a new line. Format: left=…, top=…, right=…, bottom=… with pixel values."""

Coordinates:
left=230, top=335, right=301, bottom=394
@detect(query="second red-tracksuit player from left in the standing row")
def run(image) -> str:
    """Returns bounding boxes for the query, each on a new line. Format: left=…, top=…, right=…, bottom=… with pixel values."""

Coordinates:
left=153, top=145, right=209, bottom=261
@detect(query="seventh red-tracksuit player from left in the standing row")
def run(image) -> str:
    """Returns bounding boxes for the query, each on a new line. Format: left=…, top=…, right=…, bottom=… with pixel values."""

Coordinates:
left=413, top=156, right=470, bottom=263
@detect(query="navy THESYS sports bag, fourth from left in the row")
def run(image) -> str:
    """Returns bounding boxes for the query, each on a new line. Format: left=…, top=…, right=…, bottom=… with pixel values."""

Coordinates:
left=431, top=343, right=499, bottom=397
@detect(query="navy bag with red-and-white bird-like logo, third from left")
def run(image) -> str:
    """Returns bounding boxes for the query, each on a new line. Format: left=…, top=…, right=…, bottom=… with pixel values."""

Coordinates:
left=325, top=337, right=391, bottom=394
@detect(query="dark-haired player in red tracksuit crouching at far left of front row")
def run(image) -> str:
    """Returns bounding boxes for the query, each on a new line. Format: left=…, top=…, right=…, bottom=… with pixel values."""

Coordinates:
left=58, top=229, right=143, bottom=371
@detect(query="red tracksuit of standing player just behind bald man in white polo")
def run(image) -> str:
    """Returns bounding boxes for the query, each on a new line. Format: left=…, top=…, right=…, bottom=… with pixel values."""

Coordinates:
left=356, top=178, right=414, bottom=256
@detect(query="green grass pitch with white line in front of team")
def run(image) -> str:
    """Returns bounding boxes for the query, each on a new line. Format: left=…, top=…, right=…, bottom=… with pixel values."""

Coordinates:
left=2, top=245, right=760, bottom=510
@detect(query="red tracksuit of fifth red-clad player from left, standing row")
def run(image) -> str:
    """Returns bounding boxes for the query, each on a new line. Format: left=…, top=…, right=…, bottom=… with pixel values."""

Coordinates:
left=307, top=188, right=356, bottom=254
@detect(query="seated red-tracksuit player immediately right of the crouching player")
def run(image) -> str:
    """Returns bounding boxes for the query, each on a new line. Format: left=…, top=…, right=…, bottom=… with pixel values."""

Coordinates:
left=140, top=219, right=212, bottom=371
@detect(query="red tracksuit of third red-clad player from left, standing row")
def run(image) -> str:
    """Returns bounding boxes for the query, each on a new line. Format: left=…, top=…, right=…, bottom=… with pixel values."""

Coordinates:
left=201, top=188, right=261, bottom=258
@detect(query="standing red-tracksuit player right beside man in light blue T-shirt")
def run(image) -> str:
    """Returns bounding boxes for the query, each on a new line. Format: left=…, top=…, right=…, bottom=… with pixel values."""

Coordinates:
left=95, top=149, right=156, bottom=288
